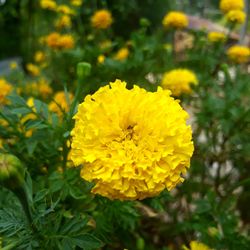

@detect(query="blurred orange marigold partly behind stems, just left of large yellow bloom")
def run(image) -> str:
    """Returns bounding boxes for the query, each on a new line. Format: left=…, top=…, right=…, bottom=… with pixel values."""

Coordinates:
left=49, top=91, right=73, bottom=116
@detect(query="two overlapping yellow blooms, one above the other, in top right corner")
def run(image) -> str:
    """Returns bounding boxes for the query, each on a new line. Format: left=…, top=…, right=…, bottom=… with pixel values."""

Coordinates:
left=220, top=0, right=246, bottom=24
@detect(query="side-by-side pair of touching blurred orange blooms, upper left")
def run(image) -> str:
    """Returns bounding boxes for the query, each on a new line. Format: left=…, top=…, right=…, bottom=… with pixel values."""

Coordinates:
left=46, top=32, right=75, bottom=49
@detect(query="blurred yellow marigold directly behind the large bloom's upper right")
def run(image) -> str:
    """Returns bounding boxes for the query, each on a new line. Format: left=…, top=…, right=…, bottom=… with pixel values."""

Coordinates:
left=161, top=69, right=198, bottom=96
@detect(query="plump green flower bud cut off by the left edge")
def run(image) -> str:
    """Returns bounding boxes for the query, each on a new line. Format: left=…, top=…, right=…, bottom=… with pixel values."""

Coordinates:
left=0, top=153, right=25, bottom=190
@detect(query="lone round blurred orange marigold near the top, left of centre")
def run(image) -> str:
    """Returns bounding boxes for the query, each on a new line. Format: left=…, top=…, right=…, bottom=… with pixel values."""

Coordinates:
left=91, top=10, right=113, bottom=29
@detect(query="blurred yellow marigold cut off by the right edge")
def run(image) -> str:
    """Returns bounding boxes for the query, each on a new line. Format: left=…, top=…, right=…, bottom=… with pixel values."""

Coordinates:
left=227, top=45, right=250, bottom=63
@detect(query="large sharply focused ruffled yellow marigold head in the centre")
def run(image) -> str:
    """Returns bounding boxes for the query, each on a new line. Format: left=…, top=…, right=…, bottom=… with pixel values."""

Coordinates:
left=71, top=80, right=194, bottom=200
